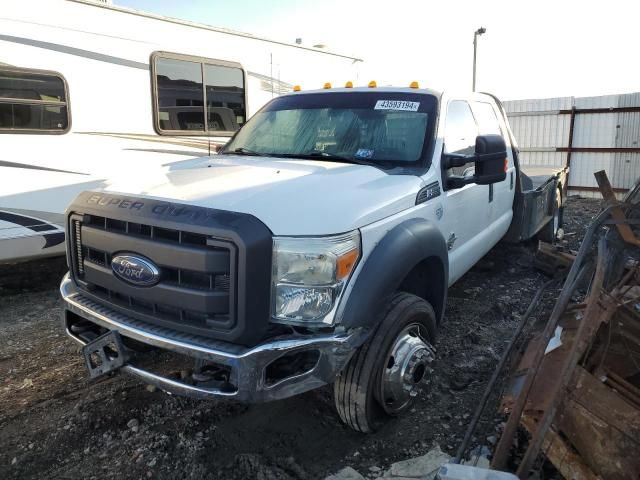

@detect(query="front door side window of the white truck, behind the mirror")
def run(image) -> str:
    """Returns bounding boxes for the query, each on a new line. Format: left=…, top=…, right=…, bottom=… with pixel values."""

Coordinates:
left=444, top=100, right=478, bottom=175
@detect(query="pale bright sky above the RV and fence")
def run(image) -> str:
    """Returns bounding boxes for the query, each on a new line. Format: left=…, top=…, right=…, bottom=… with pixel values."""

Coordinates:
left=113, top=0, right=640, bottom=100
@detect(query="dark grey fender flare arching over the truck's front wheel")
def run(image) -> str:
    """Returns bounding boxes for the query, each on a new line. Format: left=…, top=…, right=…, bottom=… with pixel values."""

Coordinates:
left=339, top=219, right=449, bottom=328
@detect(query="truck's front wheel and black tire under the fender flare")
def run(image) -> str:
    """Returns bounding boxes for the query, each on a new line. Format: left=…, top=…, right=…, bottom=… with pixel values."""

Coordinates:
left=334, top=292, right=436, bottom=433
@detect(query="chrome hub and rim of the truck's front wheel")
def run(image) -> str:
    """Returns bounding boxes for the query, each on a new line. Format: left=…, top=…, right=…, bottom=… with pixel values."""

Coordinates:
left=380, top=324, right=435, bottom=415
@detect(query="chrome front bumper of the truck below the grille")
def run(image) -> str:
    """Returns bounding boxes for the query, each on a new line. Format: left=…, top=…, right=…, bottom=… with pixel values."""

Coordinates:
left=60, top=274, right=366, bottom=402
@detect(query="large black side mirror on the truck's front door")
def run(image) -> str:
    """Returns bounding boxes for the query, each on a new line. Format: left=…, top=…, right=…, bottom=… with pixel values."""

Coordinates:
left=443, top=135, right=507, bottom=188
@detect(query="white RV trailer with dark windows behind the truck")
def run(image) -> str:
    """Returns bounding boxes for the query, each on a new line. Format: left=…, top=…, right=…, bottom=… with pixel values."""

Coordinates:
left=0, top=0, right=360, bottom=263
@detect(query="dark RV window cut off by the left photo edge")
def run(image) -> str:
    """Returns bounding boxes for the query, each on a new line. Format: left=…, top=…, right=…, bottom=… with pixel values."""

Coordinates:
left=0, top=67, right=70, bottom=133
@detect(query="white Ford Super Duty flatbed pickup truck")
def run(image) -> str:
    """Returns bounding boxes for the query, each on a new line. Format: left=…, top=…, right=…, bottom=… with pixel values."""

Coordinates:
left=61, top=85, right=566, bottom=432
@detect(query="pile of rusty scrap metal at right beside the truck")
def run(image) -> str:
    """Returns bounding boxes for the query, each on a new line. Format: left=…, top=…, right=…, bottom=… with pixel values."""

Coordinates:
left=492, top=172, right=640, bottom=480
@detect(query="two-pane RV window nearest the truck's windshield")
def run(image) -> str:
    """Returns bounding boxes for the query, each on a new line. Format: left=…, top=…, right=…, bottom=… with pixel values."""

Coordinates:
left=152, top=54, right=246, bottom=135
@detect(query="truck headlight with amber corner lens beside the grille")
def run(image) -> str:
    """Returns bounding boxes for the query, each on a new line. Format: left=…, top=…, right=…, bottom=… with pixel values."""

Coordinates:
left=271, top=230, right=360, bottom=324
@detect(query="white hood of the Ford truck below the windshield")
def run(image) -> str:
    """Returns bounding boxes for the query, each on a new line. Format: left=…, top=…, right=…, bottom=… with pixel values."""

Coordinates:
left=108, top=155, right=422, bottom=235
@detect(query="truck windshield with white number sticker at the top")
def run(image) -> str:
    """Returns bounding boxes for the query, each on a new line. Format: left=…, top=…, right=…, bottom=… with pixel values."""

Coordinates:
left=224, top=91, right=437, bottom=166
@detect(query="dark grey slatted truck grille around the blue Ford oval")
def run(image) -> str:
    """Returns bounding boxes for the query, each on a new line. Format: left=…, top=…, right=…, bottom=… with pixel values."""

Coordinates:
left=68, top=214, right=237, bottom=337
